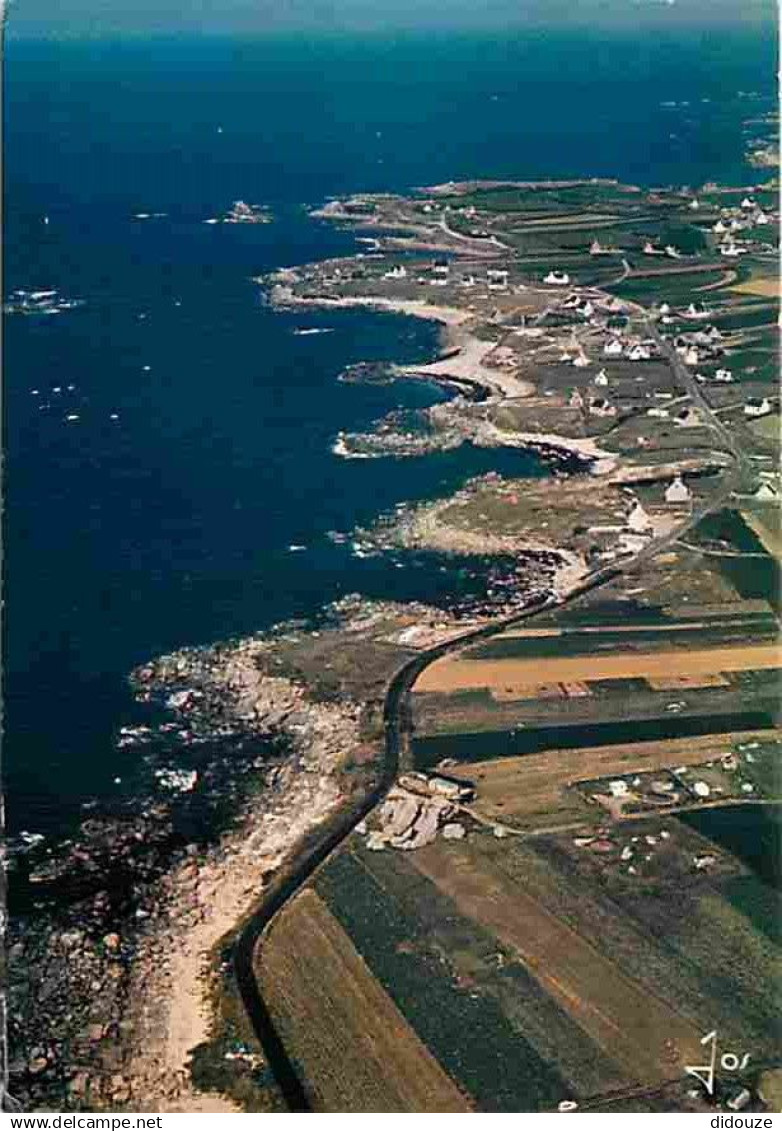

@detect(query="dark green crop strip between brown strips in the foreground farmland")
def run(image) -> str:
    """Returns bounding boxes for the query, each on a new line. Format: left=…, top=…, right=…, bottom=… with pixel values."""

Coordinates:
left=316, top=852, right=579, bottom=1112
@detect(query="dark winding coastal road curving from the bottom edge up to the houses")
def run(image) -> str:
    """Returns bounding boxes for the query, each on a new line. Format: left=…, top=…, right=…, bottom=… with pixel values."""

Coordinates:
left=233, top=287, right=746, bottom=1112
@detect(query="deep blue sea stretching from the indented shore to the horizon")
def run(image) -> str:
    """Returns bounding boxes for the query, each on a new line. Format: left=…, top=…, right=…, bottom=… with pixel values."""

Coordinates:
left=3, top=31, right=775, bottom=832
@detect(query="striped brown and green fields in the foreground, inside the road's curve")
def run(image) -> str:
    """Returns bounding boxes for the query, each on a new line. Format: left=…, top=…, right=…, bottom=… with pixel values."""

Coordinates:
left=253, top=817, right=780, bottom=1112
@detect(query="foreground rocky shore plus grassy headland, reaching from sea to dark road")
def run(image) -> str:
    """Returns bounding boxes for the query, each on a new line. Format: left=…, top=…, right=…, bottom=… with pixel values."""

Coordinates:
left=8, top=595, right=464, bottom=1111
